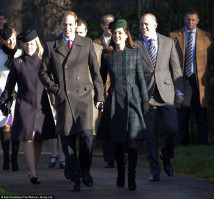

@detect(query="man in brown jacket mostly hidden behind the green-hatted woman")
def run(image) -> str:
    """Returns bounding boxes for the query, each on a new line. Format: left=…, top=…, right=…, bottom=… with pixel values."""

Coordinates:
left=93, top=14, right=115, bottom=168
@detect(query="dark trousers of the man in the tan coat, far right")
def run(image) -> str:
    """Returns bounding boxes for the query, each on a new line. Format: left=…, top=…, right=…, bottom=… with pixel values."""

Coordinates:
left=178, top=75, right=208, bottom=145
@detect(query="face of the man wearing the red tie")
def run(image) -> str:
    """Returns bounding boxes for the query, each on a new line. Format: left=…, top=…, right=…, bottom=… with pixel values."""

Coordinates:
left=62, top=15, right=77, bottom=39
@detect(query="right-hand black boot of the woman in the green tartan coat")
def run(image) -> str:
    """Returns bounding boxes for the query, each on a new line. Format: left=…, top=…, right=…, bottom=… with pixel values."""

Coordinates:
left=128, top=148, right=138, bottom=190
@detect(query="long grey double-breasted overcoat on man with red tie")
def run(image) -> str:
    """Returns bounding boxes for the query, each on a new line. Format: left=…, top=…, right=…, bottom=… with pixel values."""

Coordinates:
left=38, top=34, right=104, bottom=136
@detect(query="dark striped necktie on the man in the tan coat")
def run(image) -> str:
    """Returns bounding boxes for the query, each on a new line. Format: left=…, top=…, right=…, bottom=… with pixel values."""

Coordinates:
left=185, top=32, right=193, bottom=77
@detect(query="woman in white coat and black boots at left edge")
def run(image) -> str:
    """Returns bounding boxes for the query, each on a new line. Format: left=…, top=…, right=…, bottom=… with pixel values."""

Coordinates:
left=0, top=23, right=22, bottom=171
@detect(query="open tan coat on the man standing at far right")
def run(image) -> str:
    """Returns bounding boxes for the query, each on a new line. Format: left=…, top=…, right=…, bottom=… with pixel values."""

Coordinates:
left=170, top=28, right=214, bottom=107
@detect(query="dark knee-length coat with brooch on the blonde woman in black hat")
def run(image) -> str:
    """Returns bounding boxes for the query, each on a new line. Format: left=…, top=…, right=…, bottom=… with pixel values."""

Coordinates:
left=0, top=54, right=55, bottom=141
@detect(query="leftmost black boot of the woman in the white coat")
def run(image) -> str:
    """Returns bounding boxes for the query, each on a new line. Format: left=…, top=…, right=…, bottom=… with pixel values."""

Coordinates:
left=1, top=132, right=10, bottom=171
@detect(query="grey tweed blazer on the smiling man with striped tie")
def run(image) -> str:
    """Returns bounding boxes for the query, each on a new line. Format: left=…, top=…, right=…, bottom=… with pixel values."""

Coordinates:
left=135, top=33, right=183, bottom=105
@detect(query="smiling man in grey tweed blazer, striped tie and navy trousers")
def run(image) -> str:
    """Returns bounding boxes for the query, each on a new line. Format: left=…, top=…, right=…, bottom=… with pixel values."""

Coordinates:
left=135, top=13, right=184, bottom=181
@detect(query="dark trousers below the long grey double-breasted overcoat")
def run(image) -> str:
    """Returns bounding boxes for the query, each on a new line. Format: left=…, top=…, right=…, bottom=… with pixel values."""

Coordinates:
left=61, top=129, right=93, bottom=182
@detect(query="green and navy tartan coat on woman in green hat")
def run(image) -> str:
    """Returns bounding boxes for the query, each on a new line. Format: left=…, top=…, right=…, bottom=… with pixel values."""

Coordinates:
left=97, top=47, right=148, bottom=143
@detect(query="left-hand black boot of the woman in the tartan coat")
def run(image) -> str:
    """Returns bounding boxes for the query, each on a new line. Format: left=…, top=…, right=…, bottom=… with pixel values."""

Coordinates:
left=115, top=147, right=125, bottom=187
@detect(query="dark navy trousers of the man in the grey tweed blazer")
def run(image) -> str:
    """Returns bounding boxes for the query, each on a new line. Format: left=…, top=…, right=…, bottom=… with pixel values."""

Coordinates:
left=144, top=105, right=178, bottom=176
